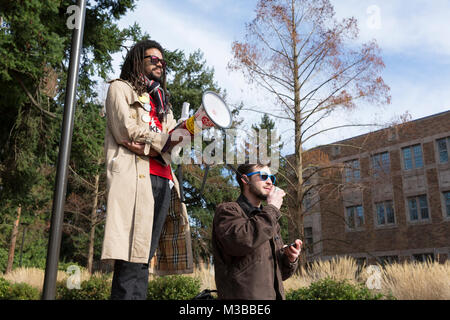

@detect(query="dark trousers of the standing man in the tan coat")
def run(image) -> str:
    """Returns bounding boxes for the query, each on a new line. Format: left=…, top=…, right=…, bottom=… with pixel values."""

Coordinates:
left=111, top=175, right=171, bottom=300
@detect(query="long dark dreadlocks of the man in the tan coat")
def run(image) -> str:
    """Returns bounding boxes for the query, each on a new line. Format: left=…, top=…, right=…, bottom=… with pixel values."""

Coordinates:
left=120, top=40, right=168, bottom=96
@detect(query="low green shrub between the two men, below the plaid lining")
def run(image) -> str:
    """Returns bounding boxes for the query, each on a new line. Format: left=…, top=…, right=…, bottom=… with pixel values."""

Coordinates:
left=147, top=275, right=201, bottom=300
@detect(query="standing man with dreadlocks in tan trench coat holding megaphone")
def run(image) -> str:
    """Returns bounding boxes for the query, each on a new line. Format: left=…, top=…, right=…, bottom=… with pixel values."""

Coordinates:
left=102, top=40, right=193, bottom=300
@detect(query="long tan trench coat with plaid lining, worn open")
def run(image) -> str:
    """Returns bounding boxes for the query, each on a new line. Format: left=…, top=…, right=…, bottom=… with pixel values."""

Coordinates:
left=101, top=79, right=193, bottom=275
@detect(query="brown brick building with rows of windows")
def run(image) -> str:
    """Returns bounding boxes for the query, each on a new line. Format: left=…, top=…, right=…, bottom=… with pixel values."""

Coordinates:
left=303, top=111, right=450, bottom=264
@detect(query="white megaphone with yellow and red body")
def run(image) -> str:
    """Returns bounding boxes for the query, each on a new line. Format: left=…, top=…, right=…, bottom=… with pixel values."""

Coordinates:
left=169, top=91, right=232, bottom=148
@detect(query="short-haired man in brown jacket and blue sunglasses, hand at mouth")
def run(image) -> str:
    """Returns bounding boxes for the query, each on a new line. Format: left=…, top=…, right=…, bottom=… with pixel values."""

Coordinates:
left=212, top=164, right=302, bottom=300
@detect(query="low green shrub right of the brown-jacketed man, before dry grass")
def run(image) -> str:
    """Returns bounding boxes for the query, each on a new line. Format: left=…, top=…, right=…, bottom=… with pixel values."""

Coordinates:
left=286, top=278, right=383, bottom=300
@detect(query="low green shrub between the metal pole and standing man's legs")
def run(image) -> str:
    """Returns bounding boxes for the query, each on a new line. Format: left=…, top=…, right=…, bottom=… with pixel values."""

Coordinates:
left=56, top=276, right=111, bottom=300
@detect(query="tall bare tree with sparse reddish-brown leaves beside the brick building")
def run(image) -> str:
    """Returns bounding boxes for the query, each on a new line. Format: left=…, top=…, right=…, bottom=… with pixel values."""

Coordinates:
left=229, top=0, right=390, bottom=264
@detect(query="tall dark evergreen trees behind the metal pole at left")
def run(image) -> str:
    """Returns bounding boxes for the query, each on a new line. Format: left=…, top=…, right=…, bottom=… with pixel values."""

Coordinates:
left=0, top=0, right=142, bottom=267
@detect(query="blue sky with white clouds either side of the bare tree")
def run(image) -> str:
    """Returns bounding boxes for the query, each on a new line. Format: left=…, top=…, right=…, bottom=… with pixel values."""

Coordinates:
left=111, top=0, right=450, bottom=153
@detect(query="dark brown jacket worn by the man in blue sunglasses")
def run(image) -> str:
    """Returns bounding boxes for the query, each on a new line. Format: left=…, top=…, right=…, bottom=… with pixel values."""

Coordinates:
left=212, top=195, right=297, bottom=300
